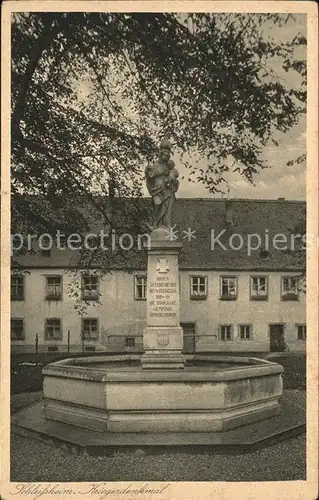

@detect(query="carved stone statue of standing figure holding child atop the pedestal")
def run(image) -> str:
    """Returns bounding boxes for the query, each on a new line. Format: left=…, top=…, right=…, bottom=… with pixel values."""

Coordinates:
left=145, top=139, right=179, bottom=229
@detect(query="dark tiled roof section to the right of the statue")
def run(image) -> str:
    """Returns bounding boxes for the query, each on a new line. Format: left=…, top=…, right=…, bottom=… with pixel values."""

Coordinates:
left=176, top=199, right=306, bottom=270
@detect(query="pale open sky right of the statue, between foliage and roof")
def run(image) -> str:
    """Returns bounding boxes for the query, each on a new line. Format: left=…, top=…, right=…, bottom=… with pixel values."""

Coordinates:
left=77, top=14, right=307, bottom=200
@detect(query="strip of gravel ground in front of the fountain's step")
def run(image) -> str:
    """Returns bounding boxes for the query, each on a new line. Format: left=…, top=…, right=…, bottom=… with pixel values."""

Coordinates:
left=11, top=435, right=306, bottom=482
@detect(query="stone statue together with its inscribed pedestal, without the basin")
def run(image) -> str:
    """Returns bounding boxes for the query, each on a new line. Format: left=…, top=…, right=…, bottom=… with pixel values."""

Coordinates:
left=141, top=140, right=184, bottom=369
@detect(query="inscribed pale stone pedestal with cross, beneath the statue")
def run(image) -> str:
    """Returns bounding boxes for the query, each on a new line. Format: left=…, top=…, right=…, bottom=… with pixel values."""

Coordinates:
left=141, top=228, right=184, bottom=369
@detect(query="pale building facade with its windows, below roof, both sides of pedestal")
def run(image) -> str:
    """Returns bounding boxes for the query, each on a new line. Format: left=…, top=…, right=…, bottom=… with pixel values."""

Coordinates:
left=11, top=269, right=306, bottom=352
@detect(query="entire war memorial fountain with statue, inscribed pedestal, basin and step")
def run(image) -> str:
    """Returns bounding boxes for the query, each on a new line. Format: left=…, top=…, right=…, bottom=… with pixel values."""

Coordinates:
left=13, top=140, right=303, bottom=447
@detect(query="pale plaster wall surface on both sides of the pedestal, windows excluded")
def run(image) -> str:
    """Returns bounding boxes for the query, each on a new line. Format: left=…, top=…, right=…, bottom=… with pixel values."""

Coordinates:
left=11, top=269, right=306, bottom=352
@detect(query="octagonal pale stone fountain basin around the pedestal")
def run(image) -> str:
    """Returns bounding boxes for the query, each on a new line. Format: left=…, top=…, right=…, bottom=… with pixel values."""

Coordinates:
left=43, top=355, right=283, bottom=433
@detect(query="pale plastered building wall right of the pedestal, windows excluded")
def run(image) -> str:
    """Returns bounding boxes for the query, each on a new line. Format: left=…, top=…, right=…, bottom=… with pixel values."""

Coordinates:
left=181, top=271, right=306, bottom=351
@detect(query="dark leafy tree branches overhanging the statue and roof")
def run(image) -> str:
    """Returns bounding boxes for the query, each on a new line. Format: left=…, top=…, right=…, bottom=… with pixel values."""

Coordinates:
left=12, top=12, right=306, bottom=240
